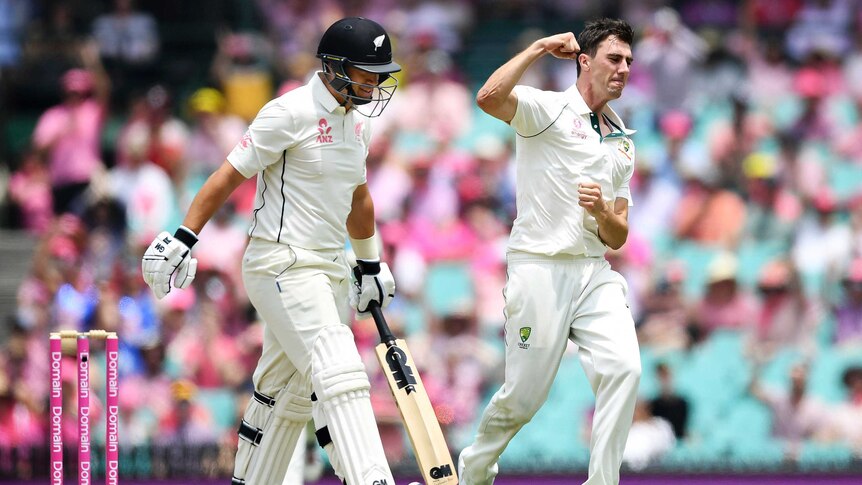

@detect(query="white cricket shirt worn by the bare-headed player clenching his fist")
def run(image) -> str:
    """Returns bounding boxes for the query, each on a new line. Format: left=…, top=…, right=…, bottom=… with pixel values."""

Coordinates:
left=509, top=85, right=635, bottom=256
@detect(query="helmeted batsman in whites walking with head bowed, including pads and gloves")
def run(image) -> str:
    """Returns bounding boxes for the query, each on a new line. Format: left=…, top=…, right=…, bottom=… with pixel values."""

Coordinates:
left=142, top=17, right=401, bottom=485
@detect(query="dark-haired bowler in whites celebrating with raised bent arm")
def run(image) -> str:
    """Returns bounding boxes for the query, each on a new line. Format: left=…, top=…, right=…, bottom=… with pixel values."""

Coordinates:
left=458, top=19, right=641, bottom=485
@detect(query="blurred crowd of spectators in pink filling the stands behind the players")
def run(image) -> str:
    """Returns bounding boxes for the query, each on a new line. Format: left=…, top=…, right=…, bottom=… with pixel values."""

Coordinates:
left=0, top=0, right=862, bottom=475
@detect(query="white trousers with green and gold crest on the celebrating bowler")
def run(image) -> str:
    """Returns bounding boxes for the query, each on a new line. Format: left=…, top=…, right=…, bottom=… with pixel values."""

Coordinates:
left=466, top=252, right=641, bottom=485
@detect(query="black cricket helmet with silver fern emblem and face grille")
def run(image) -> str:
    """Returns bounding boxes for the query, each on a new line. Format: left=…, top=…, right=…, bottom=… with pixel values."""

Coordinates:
left=317, top=17, right=401, bottom=118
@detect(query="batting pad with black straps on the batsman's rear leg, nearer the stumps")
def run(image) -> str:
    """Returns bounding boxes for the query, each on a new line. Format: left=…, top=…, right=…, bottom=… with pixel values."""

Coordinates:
left=232, top=375, right=311, bottom=485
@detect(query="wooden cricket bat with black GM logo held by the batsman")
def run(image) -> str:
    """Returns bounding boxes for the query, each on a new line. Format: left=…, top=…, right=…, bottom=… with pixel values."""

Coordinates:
left=368, top=301, right=458, bottom=485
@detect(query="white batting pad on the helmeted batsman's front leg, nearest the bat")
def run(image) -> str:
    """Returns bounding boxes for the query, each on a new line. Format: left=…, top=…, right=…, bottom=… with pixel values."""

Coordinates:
left=311, top=325, right=394, bottom=485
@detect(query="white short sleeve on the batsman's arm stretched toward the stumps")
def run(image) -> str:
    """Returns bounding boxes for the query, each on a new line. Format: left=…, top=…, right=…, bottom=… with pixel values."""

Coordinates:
left=227, top=101, right=296, bottom=178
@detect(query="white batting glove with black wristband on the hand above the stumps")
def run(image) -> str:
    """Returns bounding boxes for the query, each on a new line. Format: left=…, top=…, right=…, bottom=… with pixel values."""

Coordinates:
left=141, top=226, right=198, bottom=300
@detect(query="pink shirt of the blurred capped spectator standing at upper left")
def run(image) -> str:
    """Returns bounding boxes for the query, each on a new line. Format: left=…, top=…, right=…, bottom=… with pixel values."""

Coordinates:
left=33, top=99, right=104, bottom=187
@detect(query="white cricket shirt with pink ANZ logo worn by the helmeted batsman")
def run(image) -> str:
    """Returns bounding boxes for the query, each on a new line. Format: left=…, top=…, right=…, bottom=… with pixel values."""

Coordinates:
left=227, top=75, right=371, bottom=249
